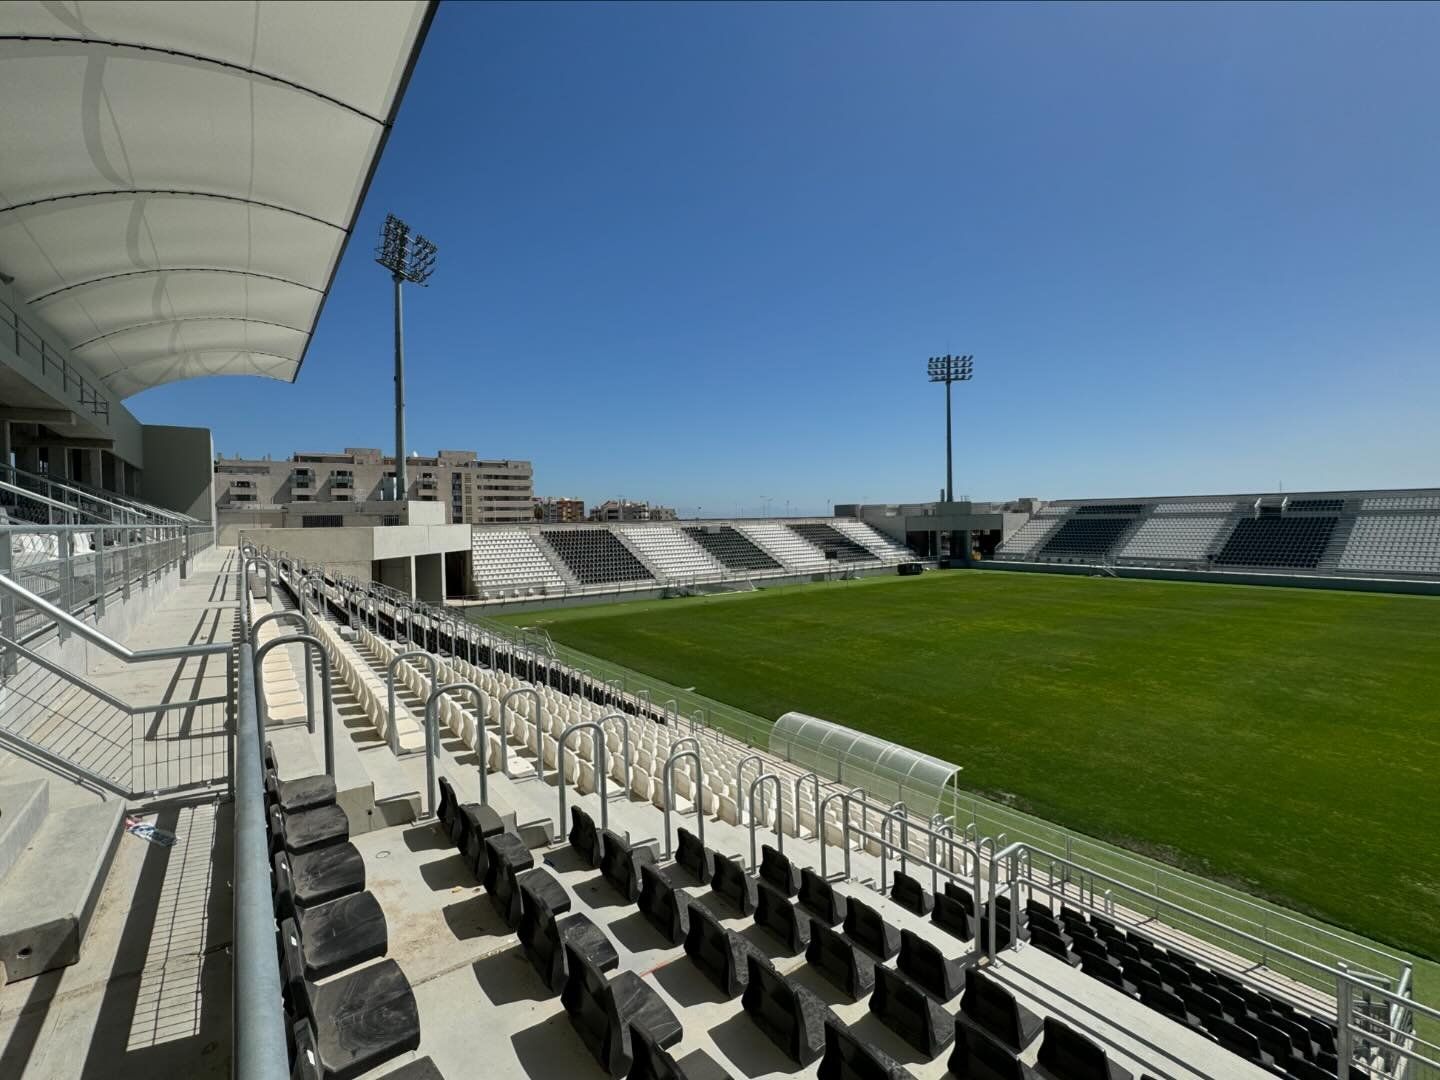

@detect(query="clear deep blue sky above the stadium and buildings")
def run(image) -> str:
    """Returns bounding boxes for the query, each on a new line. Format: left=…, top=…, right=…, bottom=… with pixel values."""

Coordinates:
left=130, top=3, right=1440, bottom=514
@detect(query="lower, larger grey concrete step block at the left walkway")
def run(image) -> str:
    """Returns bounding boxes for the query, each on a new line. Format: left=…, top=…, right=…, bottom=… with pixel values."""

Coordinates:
left=0, top=801, right=125, bottom=982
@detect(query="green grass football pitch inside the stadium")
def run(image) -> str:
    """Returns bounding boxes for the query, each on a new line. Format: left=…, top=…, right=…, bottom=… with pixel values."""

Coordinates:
left=510, top=572, right=1440, bottom=958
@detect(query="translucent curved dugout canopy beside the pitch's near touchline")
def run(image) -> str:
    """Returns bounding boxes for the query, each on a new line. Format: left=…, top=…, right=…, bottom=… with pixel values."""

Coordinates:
left=770, top=713, right=960, bottom=816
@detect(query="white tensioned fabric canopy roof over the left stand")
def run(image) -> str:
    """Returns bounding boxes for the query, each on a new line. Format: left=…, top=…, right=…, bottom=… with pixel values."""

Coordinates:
left=0, top=0, right=433, bottom=397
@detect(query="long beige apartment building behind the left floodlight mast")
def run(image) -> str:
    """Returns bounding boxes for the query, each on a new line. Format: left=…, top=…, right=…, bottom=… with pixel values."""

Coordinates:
left=215, top=446, right=534, bottom=526
